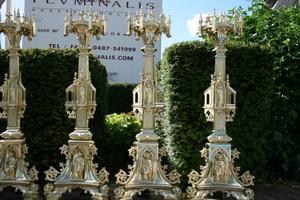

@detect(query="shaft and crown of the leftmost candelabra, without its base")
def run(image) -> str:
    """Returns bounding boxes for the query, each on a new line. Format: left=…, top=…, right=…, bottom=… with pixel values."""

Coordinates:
left=0, top=11, right=35, bottom=139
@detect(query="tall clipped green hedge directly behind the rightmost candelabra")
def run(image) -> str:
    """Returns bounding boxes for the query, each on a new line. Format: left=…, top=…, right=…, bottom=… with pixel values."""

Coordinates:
left=160, top=41, right=273, bottom=185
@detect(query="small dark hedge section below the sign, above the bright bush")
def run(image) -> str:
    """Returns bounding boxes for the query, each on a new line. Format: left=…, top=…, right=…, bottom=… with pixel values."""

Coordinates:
left=107, top=83, right=137, bottom=114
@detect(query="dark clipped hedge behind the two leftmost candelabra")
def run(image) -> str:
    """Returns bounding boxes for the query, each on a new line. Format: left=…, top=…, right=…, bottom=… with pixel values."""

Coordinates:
left=0, top=49, right=107, bottom=181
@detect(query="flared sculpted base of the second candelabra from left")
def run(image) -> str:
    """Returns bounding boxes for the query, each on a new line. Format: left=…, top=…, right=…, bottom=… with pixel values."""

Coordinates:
left=44, top=140, right=108, bottom=200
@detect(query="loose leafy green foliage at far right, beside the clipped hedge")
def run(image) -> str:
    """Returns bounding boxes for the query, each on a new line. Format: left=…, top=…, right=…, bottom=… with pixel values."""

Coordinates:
left=243, top=0, right=300, bottom=181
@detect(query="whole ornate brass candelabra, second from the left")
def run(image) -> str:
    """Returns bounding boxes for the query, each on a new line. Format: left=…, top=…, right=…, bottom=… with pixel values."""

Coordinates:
left=44, top=11, right=109, bottom=200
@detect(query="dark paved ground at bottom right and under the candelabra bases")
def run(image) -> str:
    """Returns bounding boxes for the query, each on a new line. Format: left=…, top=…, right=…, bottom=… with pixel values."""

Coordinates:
left=0, top=182, right=300, bottom=200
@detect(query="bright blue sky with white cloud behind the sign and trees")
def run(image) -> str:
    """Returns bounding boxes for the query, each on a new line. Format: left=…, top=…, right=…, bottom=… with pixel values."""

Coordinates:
left=1, top=0, right=251, bottom=49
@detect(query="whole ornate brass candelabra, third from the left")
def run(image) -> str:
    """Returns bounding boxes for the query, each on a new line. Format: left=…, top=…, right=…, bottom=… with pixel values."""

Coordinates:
left=115, top=10, right=181, bottom=200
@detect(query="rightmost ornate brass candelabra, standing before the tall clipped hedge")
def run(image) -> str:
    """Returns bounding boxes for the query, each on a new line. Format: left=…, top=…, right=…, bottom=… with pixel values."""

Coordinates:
left=187, top=13, right=254, bottom=200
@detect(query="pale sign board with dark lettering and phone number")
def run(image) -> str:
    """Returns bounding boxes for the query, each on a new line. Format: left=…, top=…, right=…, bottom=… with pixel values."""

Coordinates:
left=23, top=0, right=162, bottom=83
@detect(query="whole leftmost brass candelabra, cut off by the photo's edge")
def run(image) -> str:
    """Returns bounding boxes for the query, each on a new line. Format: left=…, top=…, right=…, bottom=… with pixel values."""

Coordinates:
left=0, top=10, right=38, bottom=199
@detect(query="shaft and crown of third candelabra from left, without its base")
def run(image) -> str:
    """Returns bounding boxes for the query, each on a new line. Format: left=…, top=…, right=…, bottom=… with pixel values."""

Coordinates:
left=128, top=10, right=171, bottom=141
